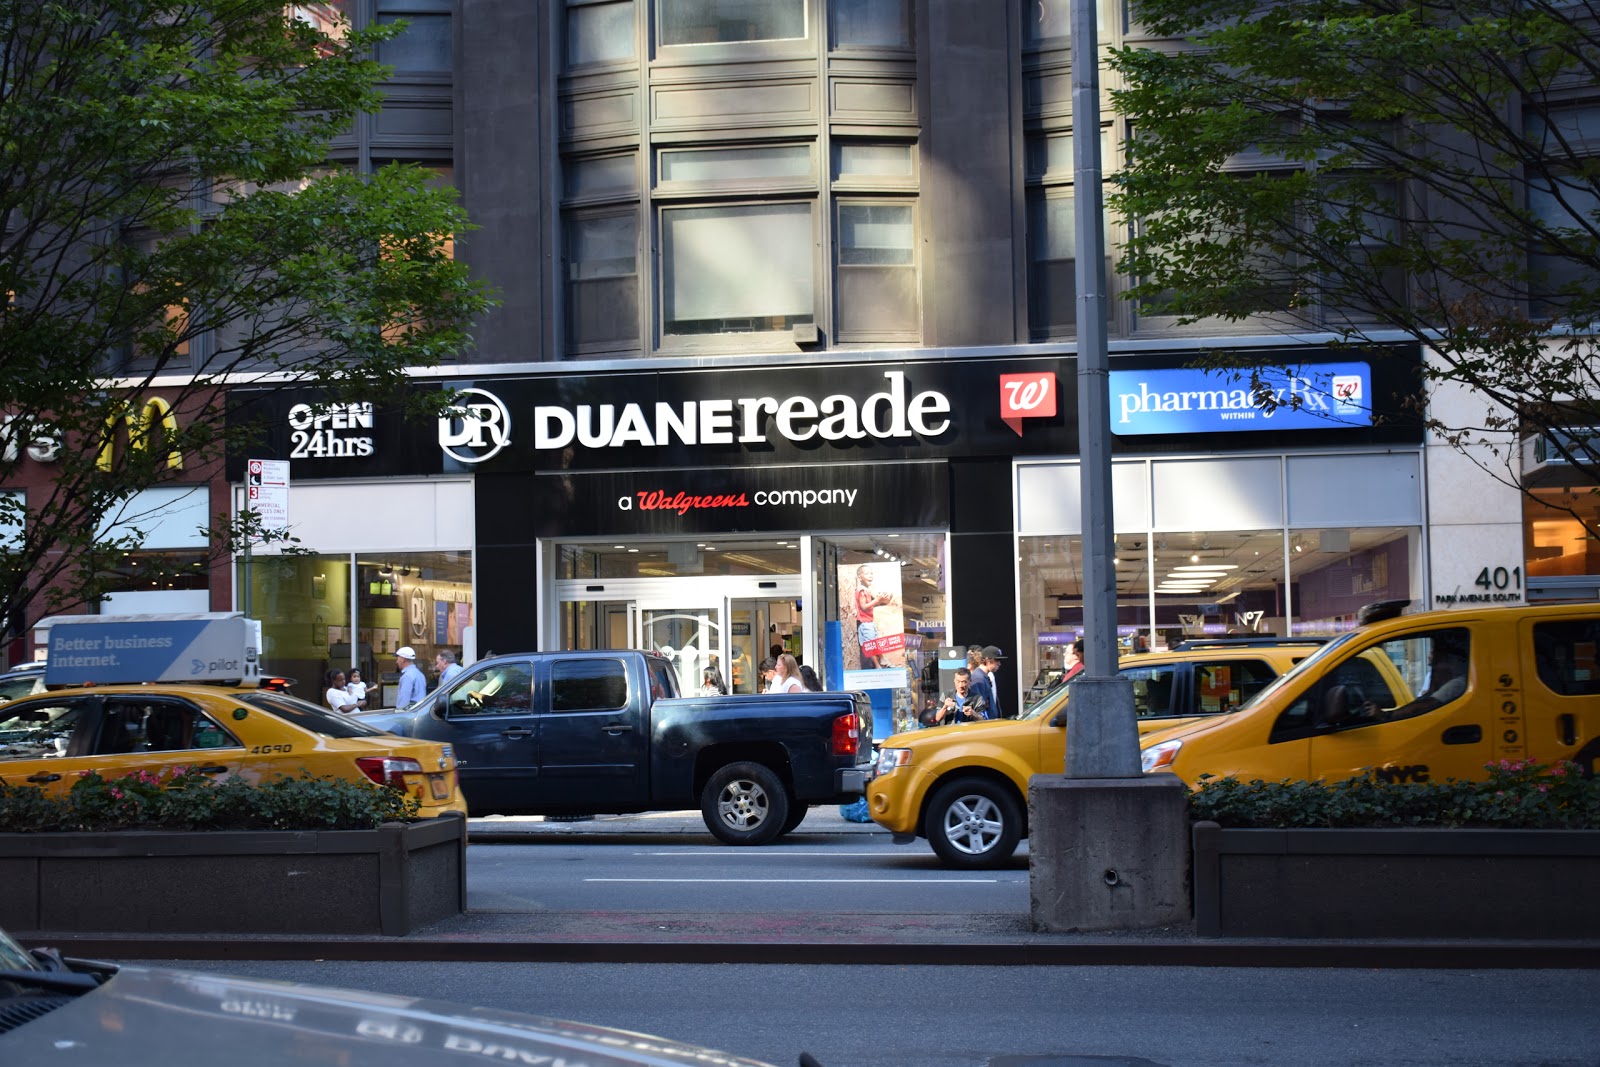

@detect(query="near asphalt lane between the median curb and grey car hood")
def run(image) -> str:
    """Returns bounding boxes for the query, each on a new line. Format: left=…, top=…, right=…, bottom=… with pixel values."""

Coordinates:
left=134, top=947, right=1600, bottom=1067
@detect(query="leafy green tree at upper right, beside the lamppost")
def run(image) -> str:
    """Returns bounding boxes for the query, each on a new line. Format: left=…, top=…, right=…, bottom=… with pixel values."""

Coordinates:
left=1109, top=0, right=1600, bottom=539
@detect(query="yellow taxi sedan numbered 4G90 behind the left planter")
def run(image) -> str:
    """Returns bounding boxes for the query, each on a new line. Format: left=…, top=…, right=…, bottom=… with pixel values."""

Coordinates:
left=0, top=685, right=467, bottom=817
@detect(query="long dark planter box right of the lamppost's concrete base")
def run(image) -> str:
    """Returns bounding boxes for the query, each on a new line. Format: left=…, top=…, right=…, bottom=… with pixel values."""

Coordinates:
left=1194, top=822, right=1600, bottom=939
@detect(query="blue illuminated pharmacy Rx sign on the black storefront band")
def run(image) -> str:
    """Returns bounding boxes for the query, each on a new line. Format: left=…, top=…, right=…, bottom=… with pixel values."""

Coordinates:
left=1110, top=363, right=1373, bottom=437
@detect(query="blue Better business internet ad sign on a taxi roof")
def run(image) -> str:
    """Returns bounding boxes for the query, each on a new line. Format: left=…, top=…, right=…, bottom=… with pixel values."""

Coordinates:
left=45, top=614, right=258, bottom=685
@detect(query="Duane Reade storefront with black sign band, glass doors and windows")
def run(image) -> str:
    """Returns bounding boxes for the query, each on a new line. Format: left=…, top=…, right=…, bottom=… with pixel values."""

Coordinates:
left=230, top=347, right=1421, bottom=733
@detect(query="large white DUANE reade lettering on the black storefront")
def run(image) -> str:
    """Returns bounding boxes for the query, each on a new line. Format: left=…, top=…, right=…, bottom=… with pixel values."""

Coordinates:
left=533, top=371, right=950, bottom=450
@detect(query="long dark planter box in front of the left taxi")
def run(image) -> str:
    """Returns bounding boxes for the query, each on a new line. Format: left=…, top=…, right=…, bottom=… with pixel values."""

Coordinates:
left=0, top=817, right=467, bottom=936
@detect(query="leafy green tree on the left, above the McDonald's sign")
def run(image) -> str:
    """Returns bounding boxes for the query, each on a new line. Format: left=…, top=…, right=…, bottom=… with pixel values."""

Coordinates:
left=0, top=0, right=491, bottom=638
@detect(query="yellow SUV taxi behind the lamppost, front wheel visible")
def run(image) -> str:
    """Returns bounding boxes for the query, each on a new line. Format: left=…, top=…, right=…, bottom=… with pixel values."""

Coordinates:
left=867, top=637, right=1320, bottom=870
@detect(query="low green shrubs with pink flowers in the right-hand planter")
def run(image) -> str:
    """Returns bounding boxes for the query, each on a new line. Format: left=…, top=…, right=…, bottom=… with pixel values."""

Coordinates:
left=1189, top=760, right=1600, bottom=830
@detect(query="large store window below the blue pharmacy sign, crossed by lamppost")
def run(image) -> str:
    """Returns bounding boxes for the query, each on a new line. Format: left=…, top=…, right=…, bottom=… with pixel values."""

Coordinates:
left=1018, top=453, right=1422, bottom=697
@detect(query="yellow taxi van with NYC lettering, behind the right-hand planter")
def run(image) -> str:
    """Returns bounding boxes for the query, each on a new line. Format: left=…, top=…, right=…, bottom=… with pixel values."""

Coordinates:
left=1141, top=600, right=1600, bottom=787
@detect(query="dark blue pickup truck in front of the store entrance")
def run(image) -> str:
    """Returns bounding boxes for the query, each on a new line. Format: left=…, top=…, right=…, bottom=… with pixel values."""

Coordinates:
left=357, top=651, right=872, bottom=845
